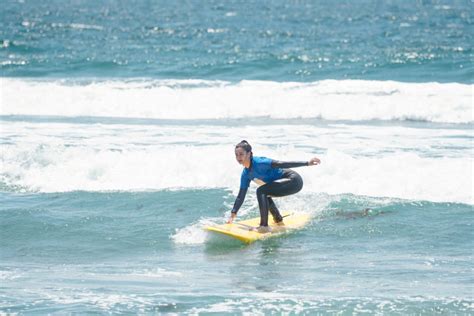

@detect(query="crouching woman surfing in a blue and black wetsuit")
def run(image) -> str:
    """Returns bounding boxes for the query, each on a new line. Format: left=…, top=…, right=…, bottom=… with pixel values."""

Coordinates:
left=227, top=140, right=321, bottom=233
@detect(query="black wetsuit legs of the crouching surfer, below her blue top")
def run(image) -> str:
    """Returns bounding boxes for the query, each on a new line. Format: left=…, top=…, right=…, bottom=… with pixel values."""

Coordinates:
left=257, top=169, right=303, bottom=226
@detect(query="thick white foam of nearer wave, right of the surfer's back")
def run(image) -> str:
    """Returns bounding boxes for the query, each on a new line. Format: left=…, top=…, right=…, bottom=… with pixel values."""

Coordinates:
left=301, top=150, right=474, bottom=204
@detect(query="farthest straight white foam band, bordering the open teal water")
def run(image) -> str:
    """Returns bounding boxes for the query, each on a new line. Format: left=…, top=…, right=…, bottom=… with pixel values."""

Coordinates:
left=0, top=78, right=474, bottom=123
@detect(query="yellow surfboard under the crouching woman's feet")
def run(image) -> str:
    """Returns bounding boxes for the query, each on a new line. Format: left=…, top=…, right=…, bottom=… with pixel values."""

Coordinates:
left=204, top=212, right=311, bottom=244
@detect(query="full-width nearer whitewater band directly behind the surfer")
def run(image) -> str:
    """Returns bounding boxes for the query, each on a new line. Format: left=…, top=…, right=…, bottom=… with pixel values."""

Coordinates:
left=0, top=112, right=474, bottom=204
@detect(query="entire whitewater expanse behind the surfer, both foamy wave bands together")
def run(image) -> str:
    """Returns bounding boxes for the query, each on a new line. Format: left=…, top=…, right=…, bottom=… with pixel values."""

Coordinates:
left=0, top=78, right=474, bottom=204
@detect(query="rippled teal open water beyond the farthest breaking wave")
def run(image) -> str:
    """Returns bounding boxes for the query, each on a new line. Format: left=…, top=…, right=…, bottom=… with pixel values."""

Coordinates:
left=0, top=0, right=473, bottom=82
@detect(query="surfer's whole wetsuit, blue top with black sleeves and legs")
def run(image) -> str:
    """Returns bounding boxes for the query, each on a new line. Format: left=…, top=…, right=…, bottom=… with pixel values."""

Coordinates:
left=232, top=157, right=308, bottom=226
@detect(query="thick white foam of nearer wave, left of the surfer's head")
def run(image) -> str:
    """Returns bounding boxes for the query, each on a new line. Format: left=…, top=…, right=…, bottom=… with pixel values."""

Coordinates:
left=0, top=145, right=238, bottom=192
